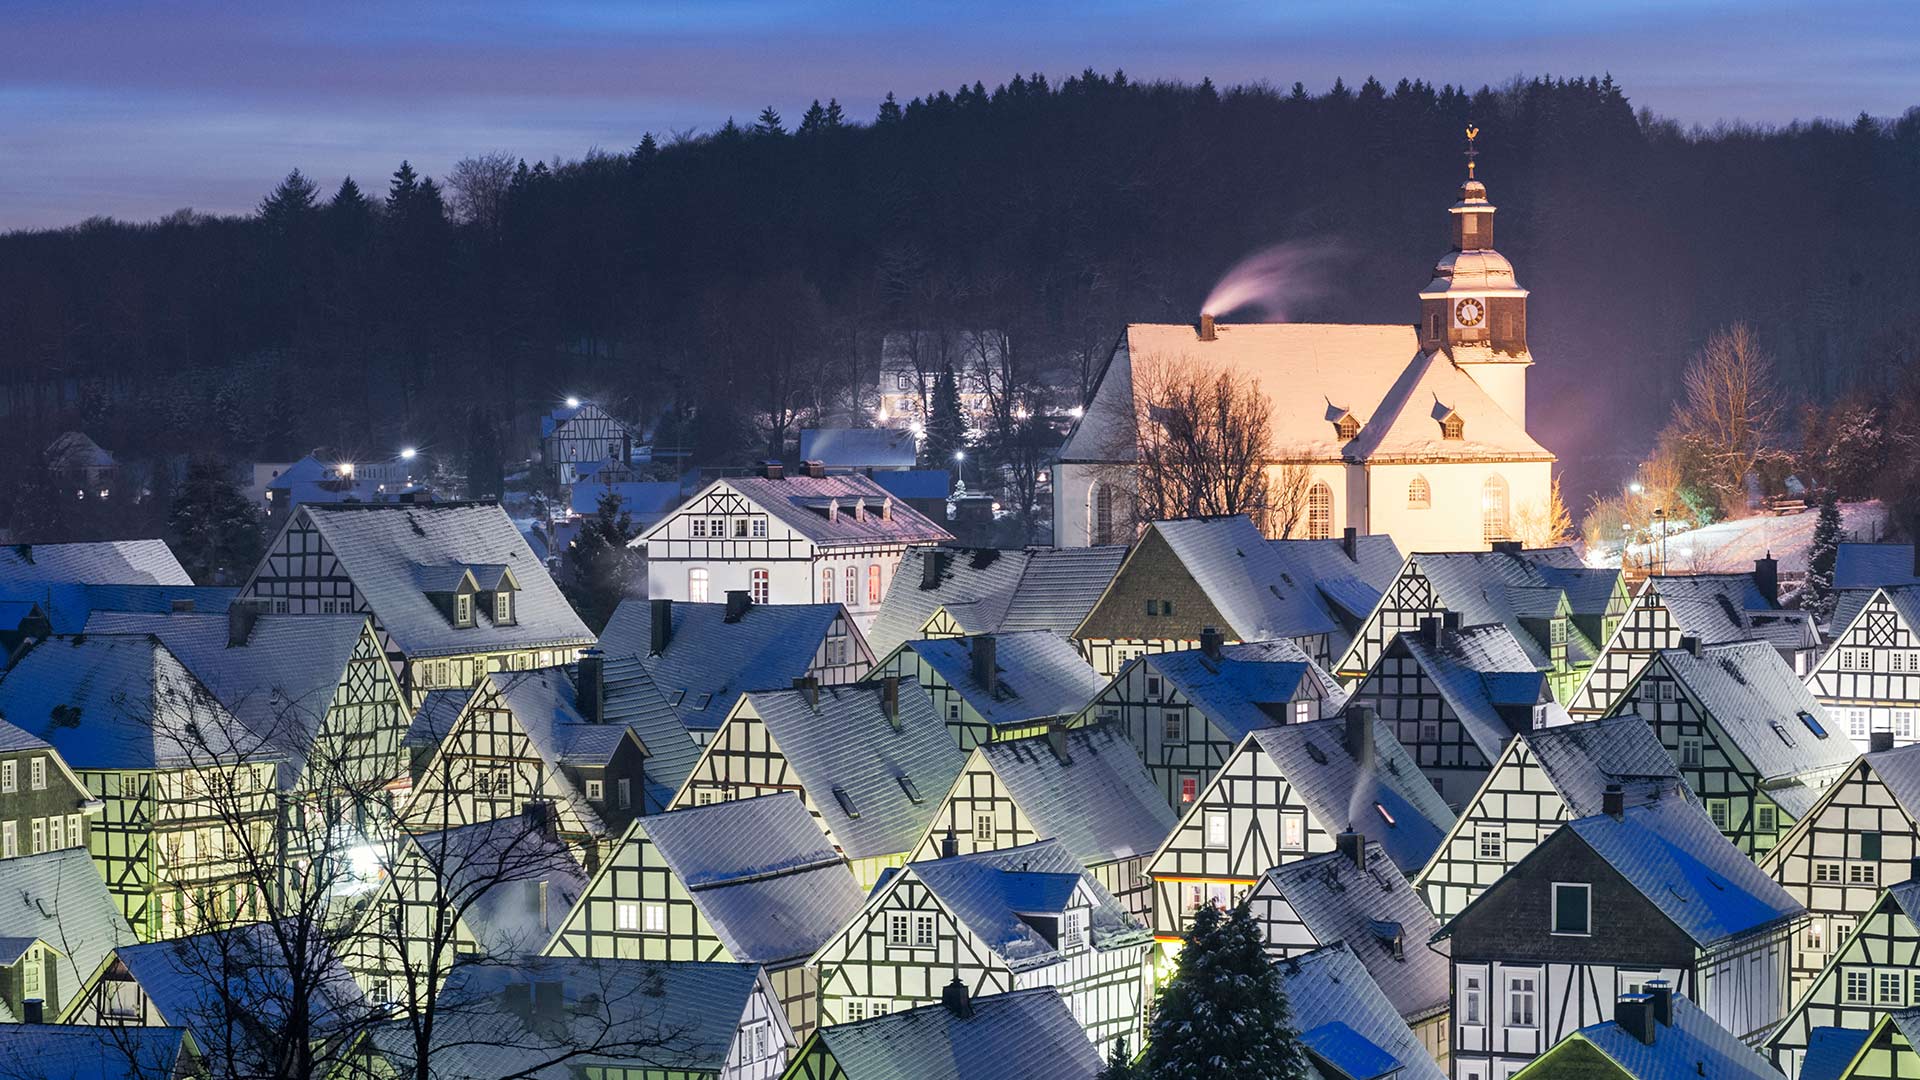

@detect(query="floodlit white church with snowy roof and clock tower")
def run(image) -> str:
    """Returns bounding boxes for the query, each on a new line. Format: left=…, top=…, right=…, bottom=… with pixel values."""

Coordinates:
left=1054, top=147, right=1553, bottom=552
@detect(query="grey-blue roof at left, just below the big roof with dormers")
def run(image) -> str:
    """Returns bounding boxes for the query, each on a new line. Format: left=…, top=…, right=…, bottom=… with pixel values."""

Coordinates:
left=86, top=611, right=378, bottom=788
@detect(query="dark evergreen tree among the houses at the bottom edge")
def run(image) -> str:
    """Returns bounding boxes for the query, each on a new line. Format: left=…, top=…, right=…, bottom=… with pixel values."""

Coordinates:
left=1140, top=903, right=1308, bottom=1080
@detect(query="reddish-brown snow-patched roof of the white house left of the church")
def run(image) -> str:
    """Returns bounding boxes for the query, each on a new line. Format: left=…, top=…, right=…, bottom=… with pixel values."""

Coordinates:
left=656, top=473, right=952, bottom=548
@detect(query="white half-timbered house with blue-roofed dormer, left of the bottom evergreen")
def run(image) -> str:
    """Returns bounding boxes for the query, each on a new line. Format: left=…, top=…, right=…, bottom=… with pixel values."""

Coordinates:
left=814, top=840, right=1152, bottom=1047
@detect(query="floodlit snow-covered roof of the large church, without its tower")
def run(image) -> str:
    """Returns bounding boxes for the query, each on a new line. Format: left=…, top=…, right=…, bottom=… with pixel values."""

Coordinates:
left=1060, top=323, right=1553, bottom=463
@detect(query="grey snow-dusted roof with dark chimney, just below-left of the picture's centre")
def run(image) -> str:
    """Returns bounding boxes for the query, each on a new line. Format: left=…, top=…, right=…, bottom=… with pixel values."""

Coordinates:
left=737, top=678, right=966, bottom=859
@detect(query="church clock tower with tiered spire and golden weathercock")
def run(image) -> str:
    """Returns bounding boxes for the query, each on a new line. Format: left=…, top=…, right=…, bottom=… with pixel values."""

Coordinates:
left=1419, top=127, right=1534, bottom=427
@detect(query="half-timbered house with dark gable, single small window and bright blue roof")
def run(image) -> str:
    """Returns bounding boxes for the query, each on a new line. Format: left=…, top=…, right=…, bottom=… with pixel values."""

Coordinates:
left=1440, top=796, right=1803, bottom=1080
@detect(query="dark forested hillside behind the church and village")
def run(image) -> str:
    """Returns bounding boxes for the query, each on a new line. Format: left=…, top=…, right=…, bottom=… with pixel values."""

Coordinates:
left=0, top=73, right=1920, bottom=518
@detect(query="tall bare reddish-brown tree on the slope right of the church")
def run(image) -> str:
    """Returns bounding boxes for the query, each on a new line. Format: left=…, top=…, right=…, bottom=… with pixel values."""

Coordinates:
left=1674, top=323, right=1780, bottom=513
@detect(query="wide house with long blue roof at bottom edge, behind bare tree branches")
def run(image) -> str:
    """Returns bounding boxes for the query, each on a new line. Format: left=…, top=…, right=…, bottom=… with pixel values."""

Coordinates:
left=362, top=957, right=795, bottom=1080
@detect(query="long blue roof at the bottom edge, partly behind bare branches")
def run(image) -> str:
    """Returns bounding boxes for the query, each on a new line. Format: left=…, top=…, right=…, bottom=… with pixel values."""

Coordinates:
left=385, top=957, right=768, bottom=1080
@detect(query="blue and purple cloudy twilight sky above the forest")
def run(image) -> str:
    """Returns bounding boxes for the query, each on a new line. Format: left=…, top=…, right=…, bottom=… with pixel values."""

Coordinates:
left=0, top=0, right=1920, bottom=231
